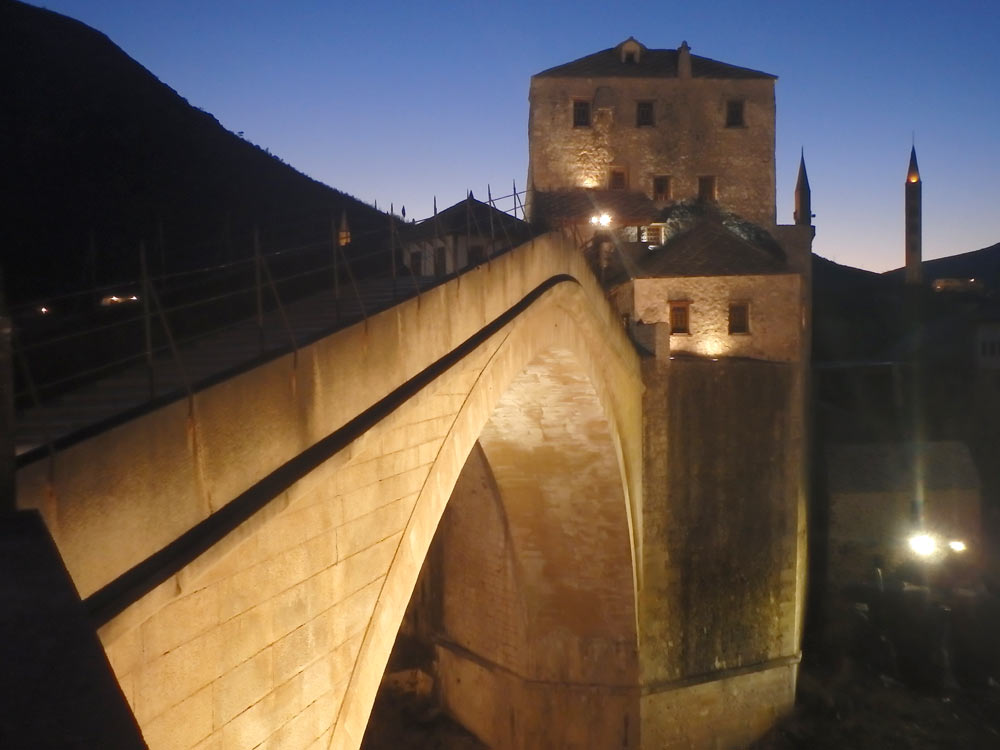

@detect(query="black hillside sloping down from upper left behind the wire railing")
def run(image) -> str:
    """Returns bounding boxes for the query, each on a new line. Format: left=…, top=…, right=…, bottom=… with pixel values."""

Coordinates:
left=0, top=0, right=388, bottom=302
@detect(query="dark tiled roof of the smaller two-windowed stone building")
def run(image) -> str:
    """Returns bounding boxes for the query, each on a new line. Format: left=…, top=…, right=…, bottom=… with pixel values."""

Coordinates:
left=624, top=219, right=788, bottom=278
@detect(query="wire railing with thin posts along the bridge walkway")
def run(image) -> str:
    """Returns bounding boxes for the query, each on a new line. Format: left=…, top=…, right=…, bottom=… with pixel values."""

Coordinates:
left=10, top=188, right=525, bottom=456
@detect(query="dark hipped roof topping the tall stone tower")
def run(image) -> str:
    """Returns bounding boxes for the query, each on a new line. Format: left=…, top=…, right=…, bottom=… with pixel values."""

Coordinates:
left=533, top=45, right=777, bottom=80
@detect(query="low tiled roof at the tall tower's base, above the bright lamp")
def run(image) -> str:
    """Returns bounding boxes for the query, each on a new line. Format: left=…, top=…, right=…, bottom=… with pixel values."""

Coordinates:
left=531, top=188, right=659, bottom=226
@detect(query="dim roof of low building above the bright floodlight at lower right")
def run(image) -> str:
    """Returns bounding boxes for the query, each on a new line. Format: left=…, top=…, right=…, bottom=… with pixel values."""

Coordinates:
left=826, top=441, right=979, bottom=494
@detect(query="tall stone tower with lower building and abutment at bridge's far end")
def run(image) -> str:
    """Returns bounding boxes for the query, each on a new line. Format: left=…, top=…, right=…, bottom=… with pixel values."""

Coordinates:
left=528, top=38, right=814, bottom=748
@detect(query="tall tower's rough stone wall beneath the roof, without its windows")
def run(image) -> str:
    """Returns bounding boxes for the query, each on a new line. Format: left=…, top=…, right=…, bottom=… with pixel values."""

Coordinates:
left=528, top=76, right=775, bottom=226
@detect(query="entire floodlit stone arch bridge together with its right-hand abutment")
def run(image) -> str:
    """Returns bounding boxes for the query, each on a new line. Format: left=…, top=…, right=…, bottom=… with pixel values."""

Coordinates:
left=17, top=234, right=804, bottom=750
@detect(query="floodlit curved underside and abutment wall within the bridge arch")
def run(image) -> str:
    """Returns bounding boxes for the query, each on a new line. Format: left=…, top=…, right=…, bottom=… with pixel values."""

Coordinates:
left=386, top=349, right=638, bottom=748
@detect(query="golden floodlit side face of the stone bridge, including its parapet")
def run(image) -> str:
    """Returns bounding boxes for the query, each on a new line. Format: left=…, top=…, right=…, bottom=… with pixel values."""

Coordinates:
left=18, top=236, right=642, bottom=748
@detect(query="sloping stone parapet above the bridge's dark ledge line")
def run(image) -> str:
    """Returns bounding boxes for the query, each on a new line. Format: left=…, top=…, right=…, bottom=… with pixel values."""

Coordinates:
left=17, top=233, right=632, bottom=597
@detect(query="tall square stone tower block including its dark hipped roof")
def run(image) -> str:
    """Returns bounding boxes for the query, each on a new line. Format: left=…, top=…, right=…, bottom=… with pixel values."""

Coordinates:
left=528, top=39, right=775, bottom=226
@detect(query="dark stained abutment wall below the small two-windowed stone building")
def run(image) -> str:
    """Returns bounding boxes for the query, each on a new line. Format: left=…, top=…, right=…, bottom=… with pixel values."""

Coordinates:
left=641, top=360, right=803, bottom=682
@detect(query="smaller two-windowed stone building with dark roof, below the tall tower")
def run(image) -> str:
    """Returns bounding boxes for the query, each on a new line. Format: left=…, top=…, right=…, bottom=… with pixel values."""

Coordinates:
left=605, top=206, right=809, bottom=362
